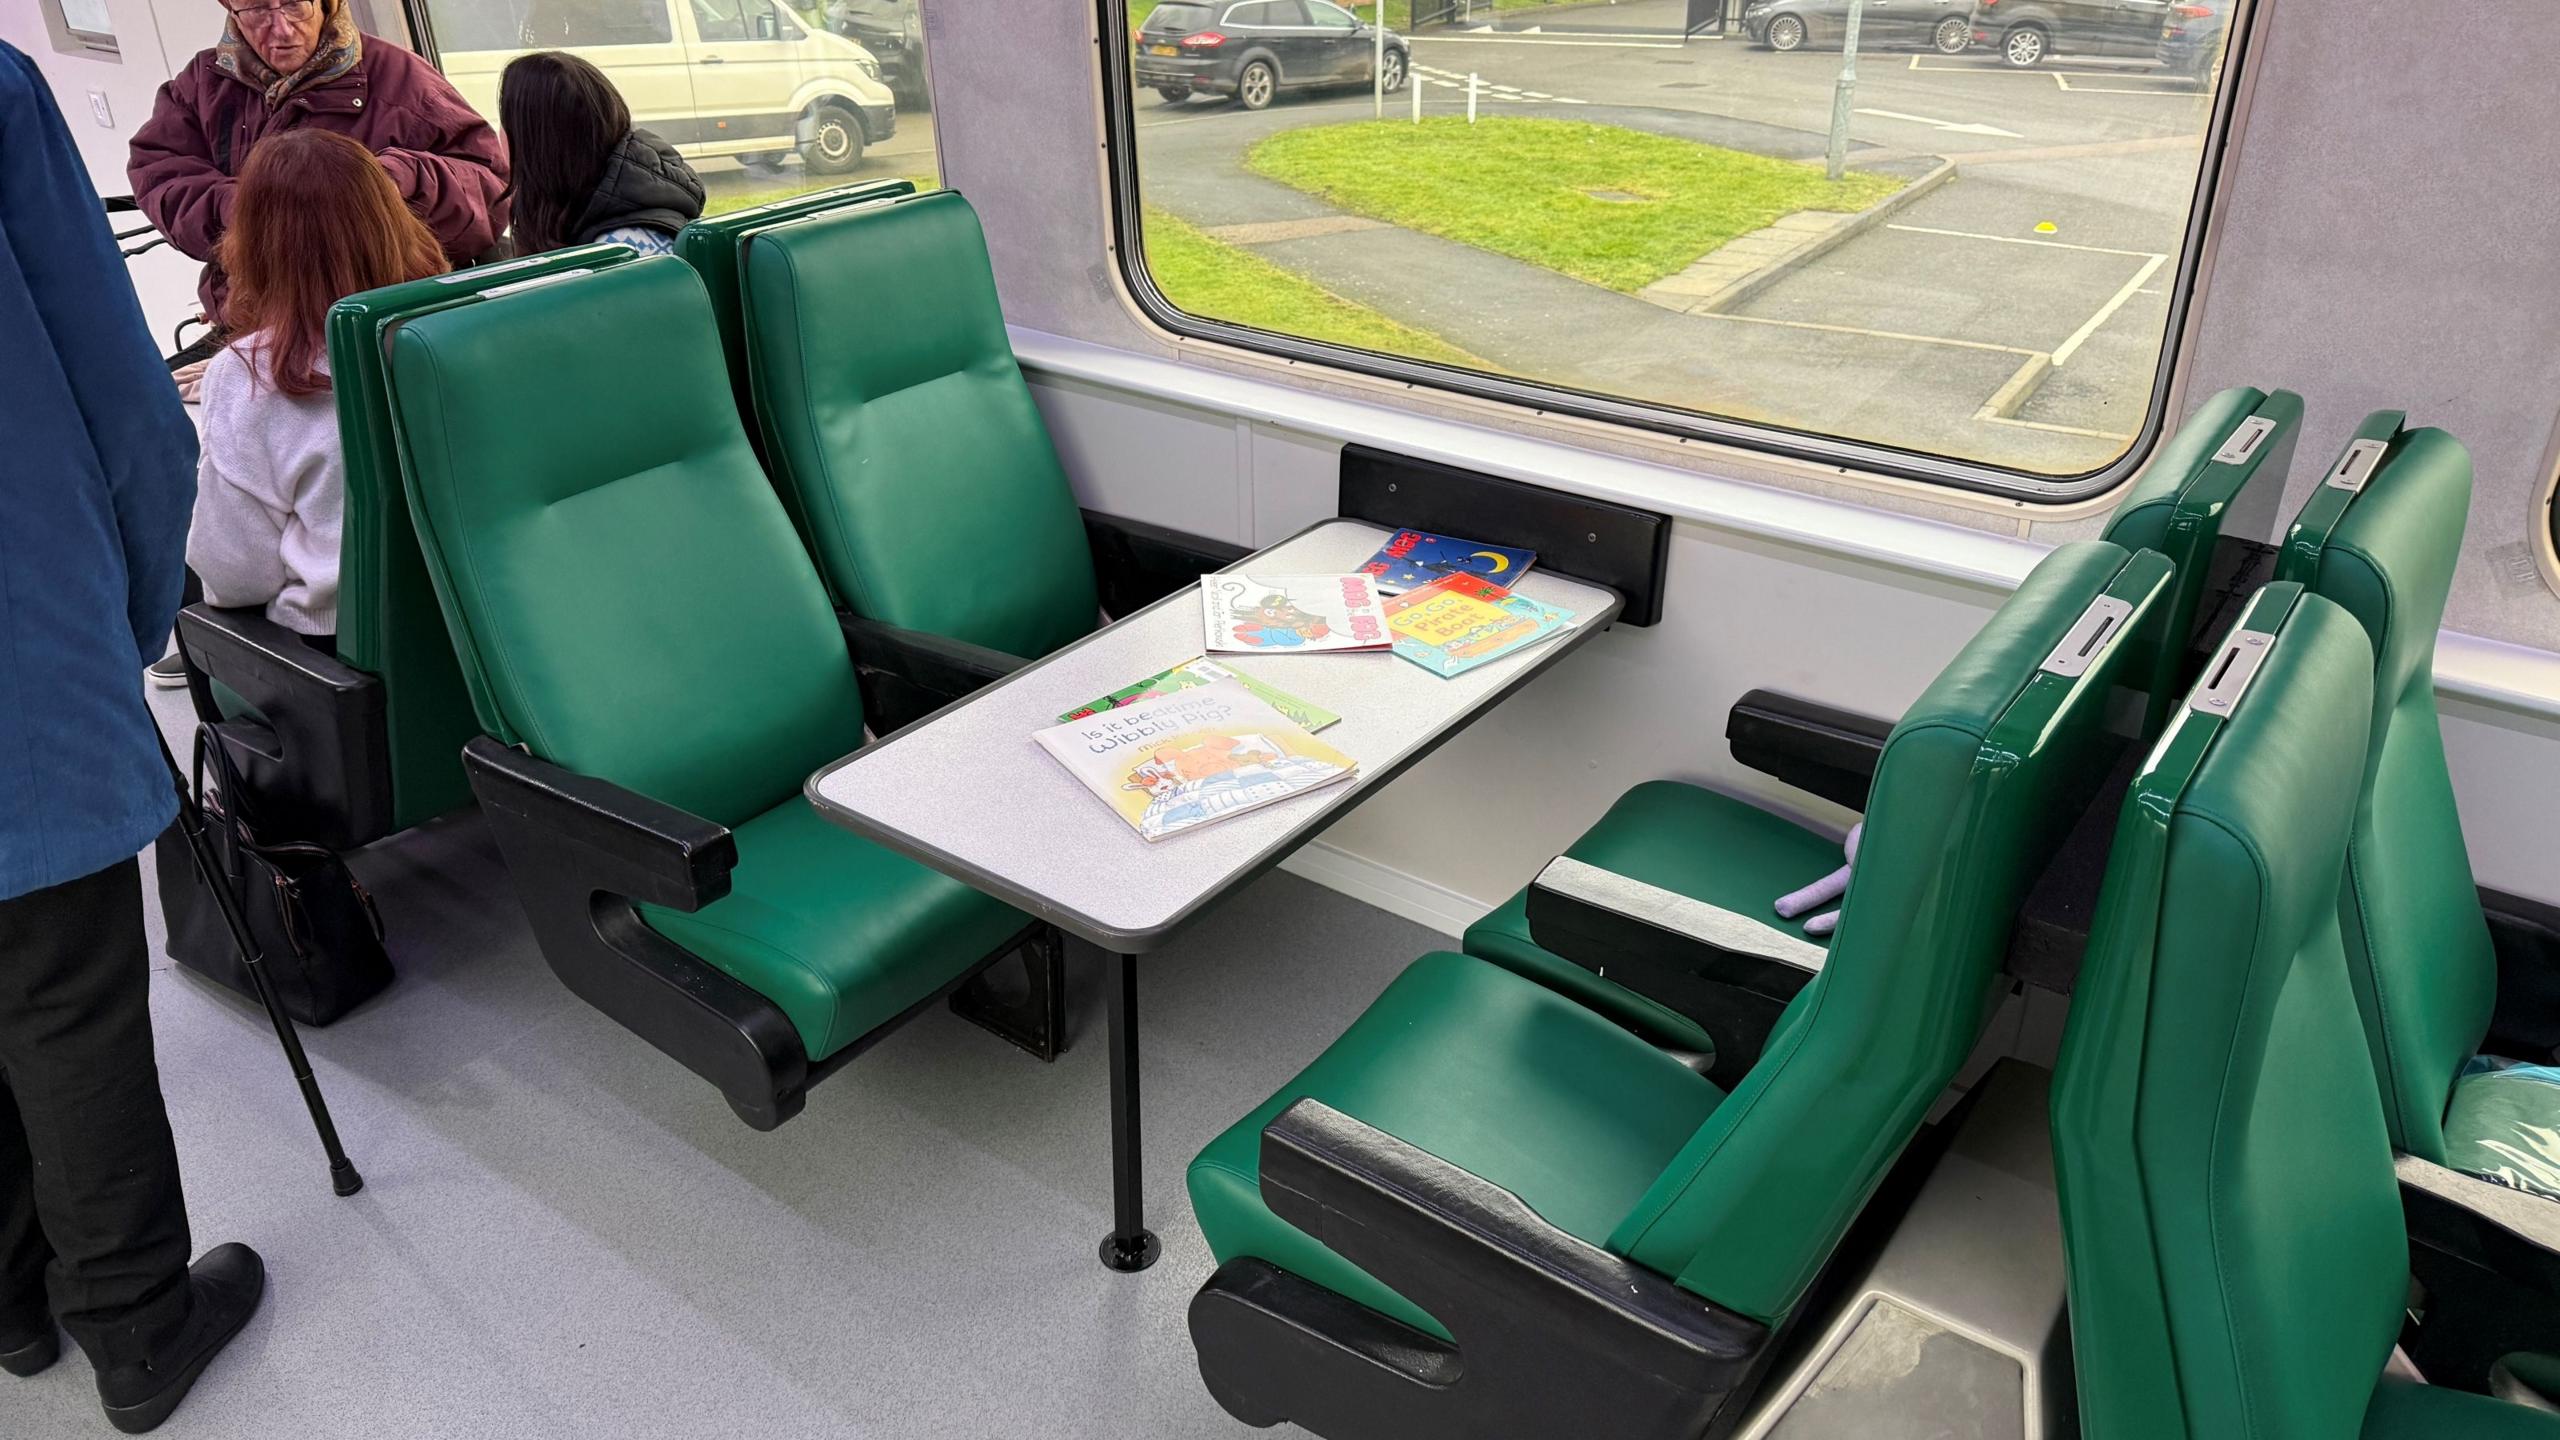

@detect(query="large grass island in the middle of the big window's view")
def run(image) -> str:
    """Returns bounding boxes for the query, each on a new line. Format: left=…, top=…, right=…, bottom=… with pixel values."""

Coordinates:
left=1244, top=115, right=1902, bottom=290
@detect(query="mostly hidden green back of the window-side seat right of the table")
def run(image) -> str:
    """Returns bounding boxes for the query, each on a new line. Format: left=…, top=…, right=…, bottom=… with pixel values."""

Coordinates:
left=2104, top=384, right=2301, bottom=728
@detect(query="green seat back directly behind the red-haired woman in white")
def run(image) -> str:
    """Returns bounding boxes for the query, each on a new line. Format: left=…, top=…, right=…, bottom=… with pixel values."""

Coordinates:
left=328, top=246, right=632, bottom=830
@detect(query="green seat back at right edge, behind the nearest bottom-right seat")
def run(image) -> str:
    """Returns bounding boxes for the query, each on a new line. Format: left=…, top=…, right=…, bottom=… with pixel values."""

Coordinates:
left=2278, top=413, right=2499, bottom=1163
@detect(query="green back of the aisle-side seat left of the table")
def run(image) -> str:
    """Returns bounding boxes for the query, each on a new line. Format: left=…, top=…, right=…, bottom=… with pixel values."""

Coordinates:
left=392, top=256, right=863, bottom=828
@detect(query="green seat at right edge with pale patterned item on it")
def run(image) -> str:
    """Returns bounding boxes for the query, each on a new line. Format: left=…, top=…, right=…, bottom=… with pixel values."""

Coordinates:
left=2278, top=410, right=2560, bottom=1386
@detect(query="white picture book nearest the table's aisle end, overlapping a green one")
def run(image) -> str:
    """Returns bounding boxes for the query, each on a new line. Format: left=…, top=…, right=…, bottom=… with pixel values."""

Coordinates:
left=1032, top=679, right=1354, bottom=840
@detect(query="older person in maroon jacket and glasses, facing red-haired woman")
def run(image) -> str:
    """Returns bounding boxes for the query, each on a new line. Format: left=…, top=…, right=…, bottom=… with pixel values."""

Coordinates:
left=125, top=0, right=507, bottom=345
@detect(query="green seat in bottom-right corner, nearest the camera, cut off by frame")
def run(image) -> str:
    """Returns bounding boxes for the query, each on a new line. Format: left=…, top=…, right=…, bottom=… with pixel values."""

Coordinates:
left=2051, top=584, right=2560, bottom=1440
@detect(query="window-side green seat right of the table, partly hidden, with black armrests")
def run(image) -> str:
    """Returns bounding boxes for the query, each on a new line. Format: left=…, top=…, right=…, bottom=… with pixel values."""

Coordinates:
left=1459, top=387, right=2301, bottom=1055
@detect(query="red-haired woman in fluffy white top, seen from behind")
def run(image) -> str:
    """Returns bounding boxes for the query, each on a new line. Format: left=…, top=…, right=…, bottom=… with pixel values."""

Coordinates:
left=187, top=128, right=448, bottom=651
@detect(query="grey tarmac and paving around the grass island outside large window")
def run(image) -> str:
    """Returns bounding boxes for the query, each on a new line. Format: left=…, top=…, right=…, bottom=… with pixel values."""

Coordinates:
left=1139, top=23, right=2209, bottom=474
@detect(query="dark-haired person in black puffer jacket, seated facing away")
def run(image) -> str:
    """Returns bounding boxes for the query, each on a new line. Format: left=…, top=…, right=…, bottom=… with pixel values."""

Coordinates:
left=497, top=51, right=701, bottom=256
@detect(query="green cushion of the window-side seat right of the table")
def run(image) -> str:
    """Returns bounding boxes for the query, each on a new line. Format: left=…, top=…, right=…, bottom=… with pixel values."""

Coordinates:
left=1459, top=779, right=1843, bottom=1053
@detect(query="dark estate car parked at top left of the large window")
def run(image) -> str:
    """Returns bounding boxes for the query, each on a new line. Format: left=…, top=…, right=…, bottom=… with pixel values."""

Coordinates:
left=1137, top=0, right=1413, bottom=110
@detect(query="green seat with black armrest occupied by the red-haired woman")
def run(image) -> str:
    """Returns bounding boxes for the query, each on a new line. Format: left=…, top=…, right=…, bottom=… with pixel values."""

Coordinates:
left=179, top=246, right=632, bottom=851
